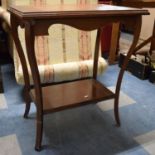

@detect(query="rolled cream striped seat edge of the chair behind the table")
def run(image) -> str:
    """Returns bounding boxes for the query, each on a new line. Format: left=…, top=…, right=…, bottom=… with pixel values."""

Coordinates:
left=15, top=57, right=107, bottom=84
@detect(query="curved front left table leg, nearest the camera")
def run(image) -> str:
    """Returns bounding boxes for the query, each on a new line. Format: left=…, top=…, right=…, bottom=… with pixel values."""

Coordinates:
left=25, top=21, right=43, bottom=151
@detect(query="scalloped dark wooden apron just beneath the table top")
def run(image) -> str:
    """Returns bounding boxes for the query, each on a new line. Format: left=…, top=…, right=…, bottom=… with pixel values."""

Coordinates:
left=19, top=15, right=141, bottom=35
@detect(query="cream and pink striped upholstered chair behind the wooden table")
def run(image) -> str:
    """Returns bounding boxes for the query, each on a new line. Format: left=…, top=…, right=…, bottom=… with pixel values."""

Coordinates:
left=2, top=0, right=107, bottom=84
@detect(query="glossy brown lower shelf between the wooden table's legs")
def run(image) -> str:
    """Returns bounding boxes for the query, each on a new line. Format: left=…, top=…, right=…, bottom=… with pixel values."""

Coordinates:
left=31, top=79, right=115, bottom=113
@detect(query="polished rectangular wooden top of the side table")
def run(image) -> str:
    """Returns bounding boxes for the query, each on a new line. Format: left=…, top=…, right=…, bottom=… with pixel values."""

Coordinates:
left=8, top=4, right=149, bottom=19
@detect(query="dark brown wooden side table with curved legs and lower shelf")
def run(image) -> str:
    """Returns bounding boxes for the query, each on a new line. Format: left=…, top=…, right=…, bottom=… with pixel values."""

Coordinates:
left=9, top=4, right=148, bottom=151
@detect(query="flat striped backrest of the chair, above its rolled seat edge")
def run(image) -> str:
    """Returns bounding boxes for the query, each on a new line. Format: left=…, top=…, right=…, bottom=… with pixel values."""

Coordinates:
left=2, top=0, right=104, bottom=84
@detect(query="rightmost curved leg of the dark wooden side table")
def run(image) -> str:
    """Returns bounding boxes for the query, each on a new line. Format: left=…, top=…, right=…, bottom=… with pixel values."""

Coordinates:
left=114, top=17, right=142, bottom=126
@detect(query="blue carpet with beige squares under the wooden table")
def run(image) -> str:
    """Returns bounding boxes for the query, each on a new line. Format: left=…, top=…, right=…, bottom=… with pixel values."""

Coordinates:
left=0, top=65, right=155, bottom=155
